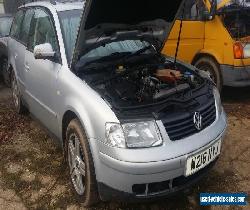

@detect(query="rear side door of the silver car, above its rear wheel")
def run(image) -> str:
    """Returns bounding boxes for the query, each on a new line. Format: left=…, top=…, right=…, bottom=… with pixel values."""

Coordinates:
left=8, top=9, right=26, bottom=93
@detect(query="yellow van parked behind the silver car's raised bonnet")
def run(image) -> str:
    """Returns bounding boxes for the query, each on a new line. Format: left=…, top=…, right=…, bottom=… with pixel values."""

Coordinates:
left=163, top=0, right=250, bottom=89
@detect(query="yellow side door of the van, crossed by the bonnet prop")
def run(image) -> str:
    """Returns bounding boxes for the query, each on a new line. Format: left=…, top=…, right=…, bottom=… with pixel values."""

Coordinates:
left=163, top=0, right=207, bottom=63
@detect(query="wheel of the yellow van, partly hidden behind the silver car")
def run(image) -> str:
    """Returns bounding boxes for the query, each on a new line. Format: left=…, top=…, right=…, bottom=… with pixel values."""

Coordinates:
left=194, top=57, right=222, bottom=92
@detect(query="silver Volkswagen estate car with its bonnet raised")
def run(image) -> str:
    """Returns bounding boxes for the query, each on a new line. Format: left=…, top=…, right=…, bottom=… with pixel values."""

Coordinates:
left=8, top=0, right=227, bottom=206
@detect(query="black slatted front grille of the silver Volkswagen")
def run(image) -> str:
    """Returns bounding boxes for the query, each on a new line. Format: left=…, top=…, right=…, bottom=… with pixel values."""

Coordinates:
left=162, top=99, right=216, bottom=141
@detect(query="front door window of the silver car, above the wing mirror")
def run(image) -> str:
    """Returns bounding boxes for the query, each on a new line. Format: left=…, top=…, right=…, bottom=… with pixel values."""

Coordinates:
left=28, top=9, right=59, bottom=52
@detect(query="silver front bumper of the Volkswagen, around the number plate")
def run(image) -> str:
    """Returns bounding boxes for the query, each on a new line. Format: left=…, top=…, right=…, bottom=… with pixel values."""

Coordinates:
left=95, top=112, right=226, bottom=201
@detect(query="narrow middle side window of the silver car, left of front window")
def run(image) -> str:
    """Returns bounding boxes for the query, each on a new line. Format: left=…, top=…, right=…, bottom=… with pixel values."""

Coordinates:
left=20, top=9, right=34, bottom=45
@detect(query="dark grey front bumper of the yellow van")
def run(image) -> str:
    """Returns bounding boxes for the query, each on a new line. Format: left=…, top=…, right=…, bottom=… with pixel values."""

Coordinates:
left=220, top=65, right=250, bottom=87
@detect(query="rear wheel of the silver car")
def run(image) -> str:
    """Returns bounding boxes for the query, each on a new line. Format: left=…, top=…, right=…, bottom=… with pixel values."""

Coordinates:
left=11, top=72, right=28, bottom=114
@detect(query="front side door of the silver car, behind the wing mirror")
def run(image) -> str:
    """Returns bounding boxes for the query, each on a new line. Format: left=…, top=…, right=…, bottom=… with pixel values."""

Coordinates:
left=25, top=8, right=62, bottom=134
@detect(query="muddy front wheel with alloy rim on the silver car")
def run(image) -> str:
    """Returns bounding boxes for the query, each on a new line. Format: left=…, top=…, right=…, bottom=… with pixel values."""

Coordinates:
left=65, top=119, right=99, bottom=207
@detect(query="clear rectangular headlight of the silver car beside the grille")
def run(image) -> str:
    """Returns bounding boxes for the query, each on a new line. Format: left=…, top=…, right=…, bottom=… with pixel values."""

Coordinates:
left=106, top=121, right=162, bottom=148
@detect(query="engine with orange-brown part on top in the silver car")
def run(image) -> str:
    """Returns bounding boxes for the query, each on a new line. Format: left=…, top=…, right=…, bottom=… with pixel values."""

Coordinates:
left=100, top=66, right=201, bottom=105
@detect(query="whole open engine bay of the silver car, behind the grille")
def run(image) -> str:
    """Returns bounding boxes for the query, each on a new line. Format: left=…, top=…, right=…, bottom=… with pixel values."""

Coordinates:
left=80, top=53, right=207, bottom=108
